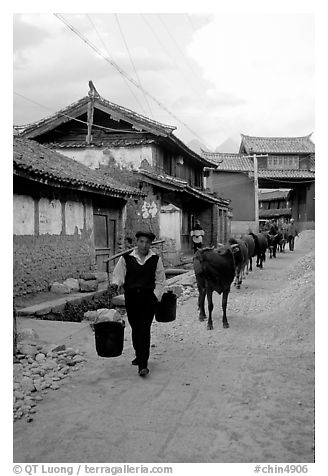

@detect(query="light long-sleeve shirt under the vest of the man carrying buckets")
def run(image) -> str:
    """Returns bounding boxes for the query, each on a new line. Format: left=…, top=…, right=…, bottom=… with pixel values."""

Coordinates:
left=112, top=250, right=165, bottom=301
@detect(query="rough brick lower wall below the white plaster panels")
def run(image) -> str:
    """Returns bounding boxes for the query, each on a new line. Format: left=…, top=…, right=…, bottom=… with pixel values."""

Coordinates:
left=14, top=231, right=95, bottom=296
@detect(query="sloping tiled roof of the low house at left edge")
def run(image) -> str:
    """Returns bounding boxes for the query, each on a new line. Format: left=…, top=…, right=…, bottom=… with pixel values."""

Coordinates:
left=13, top=137, right=144, bottom=197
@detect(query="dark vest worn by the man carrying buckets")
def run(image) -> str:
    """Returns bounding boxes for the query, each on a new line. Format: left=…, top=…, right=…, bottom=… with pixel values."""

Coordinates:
left=123, top=253, right=159, bottom=291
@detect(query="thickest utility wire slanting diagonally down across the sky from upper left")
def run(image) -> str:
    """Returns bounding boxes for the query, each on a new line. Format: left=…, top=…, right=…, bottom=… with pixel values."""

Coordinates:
left=54, top=13, right=213, bottom=148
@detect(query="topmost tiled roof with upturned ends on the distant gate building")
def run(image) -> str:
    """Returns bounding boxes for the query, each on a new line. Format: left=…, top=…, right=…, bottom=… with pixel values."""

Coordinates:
left=239, top=134, right=315, bottom=154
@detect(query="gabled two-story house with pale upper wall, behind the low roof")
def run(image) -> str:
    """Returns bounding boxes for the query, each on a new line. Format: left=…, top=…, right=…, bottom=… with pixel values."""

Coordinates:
left=18, top=82, right=230, bottom=255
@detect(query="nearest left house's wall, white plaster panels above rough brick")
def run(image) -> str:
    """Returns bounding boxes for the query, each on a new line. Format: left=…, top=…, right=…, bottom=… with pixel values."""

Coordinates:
left=13, top=183, right=125, bottom=297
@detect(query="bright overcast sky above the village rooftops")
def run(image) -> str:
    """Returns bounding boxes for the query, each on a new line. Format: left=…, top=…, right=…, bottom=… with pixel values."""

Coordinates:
left=13, top=12, right=315, bottom=150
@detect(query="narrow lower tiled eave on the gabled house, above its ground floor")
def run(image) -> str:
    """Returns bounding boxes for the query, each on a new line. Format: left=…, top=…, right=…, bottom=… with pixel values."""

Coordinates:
left=138, top=169, right=230, bottom=206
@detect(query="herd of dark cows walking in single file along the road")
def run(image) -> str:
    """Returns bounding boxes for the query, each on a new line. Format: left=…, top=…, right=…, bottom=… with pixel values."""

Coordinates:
left=193, top=232, right=287, bottom=330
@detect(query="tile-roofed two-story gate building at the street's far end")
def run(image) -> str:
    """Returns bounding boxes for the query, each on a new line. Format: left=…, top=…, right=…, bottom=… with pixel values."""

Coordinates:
left=202, top=134, right=315, bottom=235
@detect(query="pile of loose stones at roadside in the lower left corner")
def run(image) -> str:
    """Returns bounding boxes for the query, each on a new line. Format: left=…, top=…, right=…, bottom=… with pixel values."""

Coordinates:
left=13, top=342, right=87, bottom=422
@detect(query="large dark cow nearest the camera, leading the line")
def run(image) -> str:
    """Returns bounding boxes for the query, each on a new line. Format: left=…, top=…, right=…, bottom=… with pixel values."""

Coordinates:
left=193, top=244, right=239, bottom=330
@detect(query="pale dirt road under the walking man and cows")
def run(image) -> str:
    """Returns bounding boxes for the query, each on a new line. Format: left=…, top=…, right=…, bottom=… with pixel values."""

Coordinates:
left=14, top=231, right=314, bottom=463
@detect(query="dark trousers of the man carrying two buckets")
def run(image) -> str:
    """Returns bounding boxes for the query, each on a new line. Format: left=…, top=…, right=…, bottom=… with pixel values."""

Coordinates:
left=125, top=290, right=157, bottom=370
